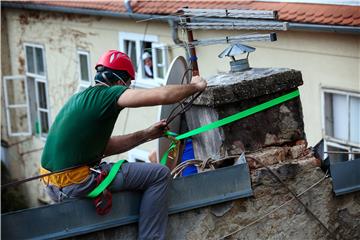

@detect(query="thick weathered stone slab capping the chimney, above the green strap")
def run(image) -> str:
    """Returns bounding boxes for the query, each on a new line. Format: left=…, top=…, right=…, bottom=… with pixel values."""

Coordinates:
left=194, top=68, right=303, bottom=107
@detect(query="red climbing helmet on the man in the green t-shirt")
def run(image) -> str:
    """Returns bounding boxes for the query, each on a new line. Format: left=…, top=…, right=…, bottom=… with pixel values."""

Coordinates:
left=95, top=50, right=135, bottom=80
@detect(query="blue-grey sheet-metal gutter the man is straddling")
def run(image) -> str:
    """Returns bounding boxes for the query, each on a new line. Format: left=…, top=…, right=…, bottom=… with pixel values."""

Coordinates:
left=1, top=162, right=253, bottom=239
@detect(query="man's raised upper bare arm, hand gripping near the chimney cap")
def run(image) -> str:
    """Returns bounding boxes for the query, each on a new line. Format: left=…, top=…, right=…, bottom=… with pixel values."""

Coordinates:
left=118, top=76, right=206, bottom=107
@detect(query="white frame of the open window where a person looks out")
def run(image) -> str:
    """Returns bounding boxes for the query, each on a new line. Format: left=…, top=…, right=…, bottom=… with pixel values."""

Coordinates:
left=119, top=32, right=168, bottom=88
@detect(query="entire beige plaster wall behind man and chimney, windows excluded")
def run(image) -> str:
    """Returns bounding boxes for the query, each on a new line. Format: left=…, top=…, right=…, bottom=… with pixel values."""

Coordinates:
left=2, top=9, right=360, bottom=205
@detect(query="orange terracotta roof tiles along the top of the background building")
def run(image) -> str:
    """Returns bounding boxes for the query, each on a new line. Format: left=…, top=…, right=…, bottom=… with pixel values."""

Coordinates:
left=5, top=0, right=360, bottom=26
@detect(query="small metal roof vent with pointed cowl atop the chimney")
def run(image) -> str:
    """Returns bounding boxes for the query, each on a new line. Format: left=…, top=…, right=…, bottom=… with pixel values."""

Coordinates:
left=218, top=43, right=255, bottom=72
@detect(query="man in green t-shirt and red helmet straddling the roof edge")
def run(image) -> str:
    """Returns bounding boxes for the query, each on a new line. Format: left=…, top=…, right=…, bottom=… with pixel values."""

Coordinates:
left=41, top=50, right=206, bottom=239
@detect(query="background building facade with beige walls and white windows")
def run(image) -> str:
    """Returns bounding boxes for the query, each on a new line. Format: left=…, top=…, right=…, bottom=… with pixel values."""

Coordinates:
left=1, top=1, right=360, bottom=206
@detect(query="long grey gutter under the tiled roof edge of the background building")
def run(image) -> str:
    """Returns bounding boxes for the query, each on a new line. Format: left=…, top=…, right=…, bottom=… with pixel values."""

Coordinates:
left=1, top=2, right=360, bottom=34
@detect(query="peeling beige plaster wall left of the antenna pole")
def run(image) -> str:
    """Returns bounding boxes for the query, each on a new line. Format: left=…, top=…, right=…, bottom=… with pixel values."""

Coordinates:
left=2, top=9, right=183, bottom=206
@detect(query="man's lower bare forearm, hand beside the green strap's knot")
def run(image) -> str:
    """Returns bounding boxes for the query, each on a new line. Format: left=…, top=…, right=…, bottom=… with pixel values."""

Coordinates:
left=104, top=120, right=166, bottom=156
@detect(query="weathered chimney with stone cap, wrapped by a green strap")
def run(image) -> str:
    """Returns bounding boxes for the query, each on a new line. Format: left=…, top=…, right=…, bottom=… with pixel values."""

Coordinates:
left=186, top=68, right=306, bottom=159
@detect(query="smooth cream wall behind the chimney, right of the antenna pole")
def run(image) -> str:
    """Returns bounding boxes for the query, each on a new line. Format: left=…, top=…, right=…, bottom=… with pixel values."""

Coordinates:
left=195, top=31, right=360, bottom=146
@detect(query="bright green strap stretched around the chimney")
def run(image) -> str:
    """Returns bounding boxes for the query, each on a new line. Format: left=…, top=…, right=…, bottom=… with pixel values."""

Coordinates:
left=160, top=89, right=300, bottom=165
